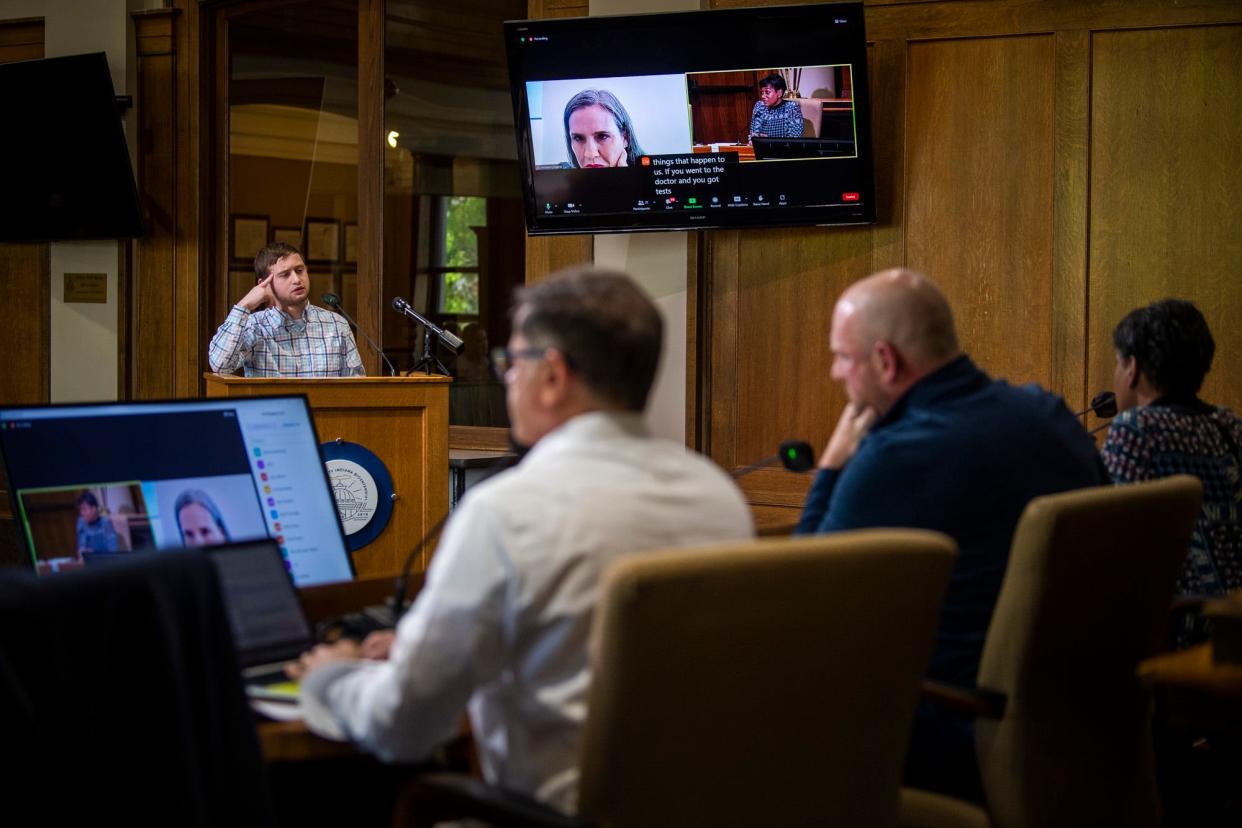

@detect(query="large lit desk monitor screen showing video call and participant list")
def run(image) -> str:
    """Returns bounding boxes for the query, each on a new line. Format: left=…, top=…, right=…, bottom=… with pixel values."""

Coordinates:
left=0, top=396, right=353, bottom=586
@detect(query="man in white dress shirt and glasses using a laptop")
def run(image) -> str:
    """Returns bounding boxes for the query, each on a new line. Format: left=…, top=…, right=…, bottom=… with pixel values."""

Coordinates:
left=295, top=269, right=754, bottom=813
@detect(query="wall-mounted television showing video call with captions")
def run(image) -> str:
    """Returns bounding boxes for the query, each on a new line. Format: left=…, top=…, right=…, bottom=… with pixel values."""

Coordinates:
left=505, top=2, right=876, bottom=235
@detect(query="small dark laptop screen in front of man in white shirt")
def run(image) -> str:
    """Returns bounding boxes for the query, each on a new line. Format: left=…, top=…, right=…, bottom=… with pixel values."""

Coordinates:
left=210, top=540, right=314, bottom=668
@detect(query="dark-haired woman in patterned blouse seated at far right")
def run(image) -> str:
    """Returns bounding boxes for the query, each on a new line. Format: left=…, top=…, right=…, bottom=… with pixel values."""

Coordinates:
left=1103, top=299, right=1242, bottom=630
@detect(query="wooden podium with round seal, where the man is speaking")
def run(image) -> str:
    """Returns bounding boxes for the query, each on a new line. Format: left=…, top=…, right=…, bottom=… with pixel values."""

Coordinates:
left=204, top=372, right=452, bottom=577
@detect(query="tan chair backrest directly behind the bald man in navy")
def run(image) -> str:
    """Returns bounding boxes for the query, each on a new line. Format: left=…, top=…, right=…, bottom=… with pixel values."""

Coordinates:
left=975, top=475, right=1202, bottom=828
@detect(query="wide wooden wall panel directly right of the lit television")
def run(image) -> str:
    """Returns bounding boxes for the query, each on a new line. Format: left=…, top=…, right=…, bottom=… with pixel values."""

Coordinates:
left=905, top=35, right=1054, bottom=382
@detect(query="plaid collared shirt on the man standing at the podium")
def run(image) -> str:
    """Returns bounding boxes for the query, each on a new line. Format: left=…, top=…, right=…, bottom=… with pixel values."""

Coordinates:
left=207, top=304, right=366, bottom=377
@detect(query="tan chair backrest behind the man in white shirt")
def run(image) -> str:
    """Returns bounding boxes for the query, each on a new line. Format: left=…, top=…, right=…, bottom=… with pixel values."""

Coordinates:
left=579, top=530, right=955, bottom=827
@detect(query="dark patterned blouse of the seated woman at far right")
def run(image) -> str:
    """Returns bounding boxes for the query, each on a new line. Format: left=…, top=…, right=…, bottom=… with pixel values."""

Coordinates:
left=1102, top=400, right=1242, bottom=595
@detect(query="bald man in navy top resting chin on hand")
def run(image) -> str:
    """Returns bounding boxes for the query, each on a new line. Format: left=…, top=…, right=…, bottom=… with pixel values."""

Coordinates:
left=797, top=269, right=1108, bottom=798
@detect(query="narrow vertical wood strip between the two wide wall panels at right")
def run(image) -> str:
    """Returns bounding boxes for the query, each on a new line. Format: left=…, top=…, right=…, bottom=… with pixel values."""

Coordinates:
left=1046, top=30, right=1095, bottom=411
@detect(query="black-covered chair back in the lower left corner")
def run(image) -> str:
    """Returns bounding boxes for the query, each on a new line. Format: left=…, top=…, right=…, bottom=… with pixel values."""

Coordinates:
left=0, top=551, right=274, bottom=826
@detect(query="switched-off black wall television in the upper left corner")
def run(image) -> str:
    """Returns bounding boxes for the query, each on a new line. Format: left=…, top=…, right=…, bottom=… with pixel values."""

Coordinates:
left=0, top=52, right=143, bottom=242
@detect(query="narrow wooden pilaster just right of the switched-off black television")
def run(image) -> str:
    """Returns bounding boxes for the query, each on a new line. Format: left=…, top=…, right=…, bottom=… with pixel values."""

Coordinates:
left=132, top=10, right=178, bottom=400
